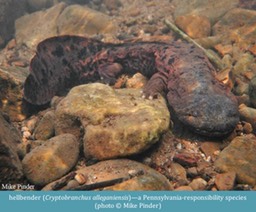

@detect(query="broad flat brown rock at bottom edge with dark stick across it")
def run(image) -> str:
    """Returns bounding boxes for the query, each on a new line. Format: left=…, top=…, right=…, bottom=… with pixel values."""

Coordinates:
left=43, top=159, right=172, bottom=191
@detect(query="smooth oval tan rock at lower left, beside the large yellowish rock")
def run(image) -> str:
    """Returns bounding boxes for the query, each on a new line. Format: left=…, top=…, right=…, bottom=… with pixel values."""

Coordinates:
left=22, top=134, right=79, bottom=186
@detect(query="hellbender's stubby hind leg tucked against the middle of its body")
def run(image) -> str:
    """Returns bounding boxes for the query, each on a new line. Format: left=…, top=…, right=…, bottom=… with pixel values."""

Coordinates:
left=97, top=63, right=123, bottom=85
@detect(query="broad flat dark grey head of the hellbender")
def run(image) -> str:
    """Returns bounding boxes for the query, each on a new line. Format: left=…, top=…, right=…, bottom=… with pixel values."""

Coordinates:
left=171, top=93, right=239, bottom=137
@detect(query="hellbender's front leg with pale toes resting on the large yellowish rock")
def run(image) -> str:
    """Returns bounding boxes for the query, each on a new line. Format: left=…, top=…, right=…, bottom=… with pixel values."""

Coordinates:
left=142, top=72, right=167, bottom=99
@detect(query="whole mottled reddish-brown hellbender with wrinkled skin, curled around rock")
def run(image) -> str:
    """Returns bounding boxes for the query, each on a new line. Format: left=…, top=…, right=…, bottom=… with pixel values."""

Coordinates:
left=24, top=36, right=239, bottom=136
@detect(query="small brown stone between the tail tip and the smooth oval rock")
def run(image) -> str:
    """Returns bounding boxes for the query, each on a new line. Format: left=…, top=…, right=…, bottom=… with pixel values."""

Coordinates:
left=34, top=111, right=55, bottom=140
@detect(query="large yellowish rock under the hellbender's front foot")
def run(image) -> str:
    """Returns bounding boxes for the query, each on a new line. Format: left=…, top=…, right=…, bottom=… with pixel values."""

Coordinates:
left=55, top=83, right=170, bottom=160
